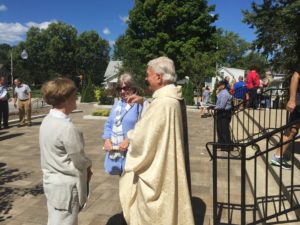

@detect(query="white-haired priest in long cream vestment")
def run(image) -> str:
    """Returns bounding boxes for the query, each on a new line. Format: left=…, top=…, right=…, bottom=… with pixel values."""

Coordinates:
left=120, top=57, right=194, bottom=225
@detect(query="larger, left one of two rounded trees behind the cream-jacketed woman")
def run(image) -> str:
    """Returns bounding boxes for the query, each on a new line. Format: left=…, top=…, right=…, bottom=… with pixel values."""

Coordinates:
left=14, top=22, right=77, bottom=85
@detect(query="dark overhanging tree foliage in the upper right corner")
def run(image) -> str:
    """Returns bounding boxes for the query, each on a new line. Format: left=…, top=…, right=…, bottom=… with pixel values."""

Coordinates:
left=243, top=0, right=300, bottom=71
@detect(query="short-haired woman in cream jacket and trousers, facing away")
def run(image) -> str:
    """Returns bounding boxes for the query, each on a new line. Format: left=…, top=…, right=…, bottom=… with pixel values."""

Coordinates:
left=39, top=78, right=92, bottom=225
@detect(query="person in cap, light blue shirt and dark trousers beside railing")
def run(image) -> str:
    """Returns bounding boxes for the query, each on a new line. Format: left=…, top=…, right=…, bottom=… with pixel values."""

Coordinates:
left=215, top=81, right=232, bottom=150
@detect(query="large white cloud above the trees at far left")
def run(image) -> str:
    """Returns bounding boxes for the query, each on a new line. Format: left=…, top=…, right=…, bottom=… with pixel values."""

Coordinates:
left=0, top=20, right=56, bottom=44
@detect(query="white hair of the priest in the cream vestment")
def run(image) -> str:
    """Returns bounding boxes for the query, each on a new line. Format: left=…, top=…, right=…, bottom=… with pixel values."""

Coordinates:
left=148, top=56, right=177, bottom=83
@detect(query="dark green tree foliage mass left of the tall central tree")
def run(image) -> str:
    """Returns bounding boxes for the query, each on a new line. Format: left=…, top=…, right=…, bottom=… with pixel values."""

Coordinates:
left=6, top=22, right=109, bottom=85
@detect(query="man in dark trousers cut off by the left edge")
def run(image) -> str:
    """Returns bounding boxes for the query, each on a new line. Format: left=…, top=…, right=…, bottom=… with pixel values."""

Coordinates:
left=0, top=76, right=8, bottom=130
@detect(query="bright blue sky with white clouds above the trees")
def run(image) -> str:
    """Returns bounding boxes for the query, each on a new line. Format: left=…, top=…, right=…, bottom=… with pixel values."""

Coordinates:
left=0, top=0, right=261, bottom=45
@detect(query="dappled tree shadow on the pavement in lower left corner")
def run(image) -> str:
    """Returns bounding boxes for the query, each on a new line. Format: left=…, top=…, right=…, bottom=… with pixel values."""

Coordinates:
left=0, top=162, right=43, bottom=223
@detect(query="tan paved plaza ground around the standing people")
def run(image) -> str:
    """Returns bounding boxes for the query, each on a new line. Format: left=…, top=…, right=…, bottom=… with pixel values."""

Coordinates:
left=0, top=104, right=213, bottom=225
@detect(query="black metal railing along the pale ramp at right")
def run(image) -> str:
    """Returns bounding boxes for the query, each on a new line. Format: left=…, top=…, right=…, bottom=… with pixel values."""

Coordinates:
left=206, top=89, right=300, bottom=225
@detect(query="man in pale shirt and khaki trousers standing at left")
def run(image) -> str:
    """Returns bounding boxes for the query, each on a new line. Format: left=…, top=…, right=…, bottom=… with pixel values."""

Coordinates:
left=14, top=78, right=31, bottom=126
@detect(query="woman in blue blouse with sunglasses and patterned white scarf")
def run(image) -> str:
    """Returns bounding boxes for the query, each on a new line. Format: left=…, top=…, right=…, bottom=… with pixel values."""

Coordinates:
left=102, top=73, right=143, bottom=175
